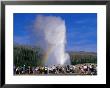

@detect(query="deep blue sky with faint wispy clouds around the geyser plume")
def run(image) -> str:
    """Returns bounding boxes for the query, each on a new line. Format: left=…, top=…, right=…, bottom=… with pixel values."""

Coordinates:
left=14, top=13, right=97, bottom=52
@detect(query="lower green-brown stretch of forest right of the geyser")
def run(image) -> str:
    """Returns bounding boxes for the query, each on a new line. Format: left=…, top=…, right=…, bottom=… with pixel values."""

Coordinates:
left=70, top=52, right=97, bottom=65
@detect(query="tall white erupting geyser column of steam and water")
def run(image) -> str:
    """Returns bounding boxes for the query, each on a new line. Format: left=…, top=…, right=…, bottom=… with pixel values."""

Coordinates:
left=35, top=15, right=70, bottom=66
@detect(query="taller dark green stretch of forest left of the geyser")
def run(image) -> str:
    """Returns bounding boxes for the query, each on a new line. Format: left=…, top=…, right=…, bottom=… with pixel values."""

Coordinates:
left=14, top=45, right=43, bottom=66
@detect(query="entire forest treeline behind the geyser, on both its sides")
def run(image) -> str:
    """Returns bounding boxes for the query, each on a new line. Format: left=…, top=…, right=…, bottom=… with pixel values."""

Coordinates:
left=14, top=45, right=97, bottom=66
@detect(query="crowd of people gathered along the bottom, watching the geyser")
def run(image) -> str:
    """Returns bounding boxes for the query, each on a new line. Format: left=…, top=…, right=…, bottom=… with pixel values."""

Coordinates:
left=14, top=64, right=97, bottom=75
